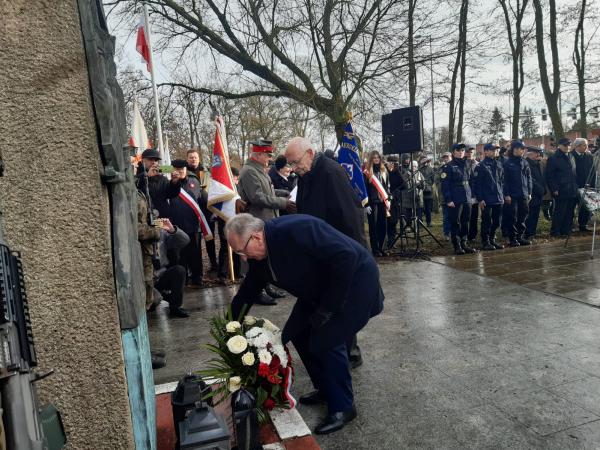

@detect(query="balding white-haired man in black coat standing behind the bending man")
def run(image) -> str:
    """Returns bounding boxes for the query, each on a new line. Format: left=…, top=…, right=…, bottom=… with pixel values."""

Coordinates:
left=285, top=137, right=367, bottom=369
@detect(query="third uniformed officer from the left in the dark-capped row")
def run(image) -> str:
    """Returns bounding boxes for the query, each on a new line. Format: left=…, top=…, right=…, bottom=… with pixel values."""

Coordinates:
left=504, top=139, right=532, bottom=247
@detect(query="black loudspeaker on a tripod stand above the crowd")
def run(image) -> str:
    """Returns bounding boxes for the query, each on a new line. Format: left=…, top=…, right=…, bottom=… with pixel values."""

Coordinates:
left=381, top=106, right=423, bottom=155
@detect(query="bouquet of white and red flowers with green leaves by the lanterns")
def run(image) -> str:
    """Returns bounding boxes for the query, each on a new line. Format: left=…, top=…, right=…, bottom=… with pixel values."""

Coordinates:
left=199, top=313, right=296, bottom=421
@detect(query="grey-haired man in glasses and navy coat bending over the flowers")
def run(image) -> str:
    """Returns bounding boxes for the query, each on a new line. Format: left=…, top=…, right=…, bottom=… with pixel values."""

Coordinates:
left=225, top=214, right=384, bottom=434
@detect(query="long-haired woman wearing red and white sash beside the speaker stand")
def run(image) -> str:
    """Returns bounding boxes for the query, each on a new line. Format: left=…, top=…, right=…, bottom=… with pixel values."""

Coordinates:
left=364, top=150, right=390, bottom=256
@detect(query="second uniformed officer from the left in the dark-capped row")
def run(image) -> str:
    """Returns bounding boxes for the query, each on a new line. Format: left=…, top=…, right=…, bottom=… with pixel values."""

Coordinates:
left=473, top=143, right=504, bottom=250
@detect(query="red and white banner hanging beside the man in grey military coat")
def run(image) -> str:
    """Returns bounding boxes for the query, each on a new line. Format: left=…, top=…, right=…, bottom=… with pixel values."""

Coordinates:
left=207, top=116, right=240, bottom=221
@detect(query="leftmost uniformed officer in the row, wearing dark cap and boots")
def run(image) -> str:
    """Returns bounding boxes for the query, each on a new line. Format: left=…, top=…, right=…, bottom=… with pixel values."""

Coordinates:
left=440, top=143, right=476, bottom=255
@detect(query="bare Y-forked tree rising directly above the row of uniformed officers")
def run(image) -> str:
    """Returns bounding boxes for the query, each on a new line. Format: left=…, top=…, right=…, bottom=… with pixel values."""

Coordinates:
left=498, top=0, right=532, bottom=139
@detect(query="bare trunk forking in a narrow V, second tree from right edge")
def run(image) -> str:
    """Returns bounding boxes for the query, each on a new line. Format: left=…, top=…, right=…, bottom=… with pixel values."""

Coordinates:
left=533, top=0, right=565, bottom=139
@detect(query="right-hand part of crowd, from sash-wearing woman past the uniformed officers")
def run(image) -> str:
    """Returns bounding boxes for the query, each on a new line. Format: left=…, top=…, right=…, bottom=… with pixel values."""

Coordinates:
left=364, top=138, right=600, bottom=256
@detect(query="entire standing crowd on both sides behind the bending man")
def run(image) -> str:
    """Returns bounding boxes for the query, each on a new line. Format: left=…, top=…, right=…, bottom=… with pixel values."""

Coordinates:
left=136, top=131, right=600, bottom=366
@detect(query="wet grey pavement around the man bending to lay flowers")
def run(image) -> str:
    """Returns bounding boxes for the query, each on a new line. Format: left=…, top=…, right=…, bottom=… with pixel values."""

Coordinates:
left=149, top=250, right=600, bottom=450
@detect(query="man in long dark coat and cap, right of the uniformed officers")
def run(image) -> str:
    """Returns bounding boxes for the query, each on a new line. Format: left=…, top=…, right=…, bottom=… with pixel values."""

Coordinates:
left=546, top=138, right=577, bottom=236
